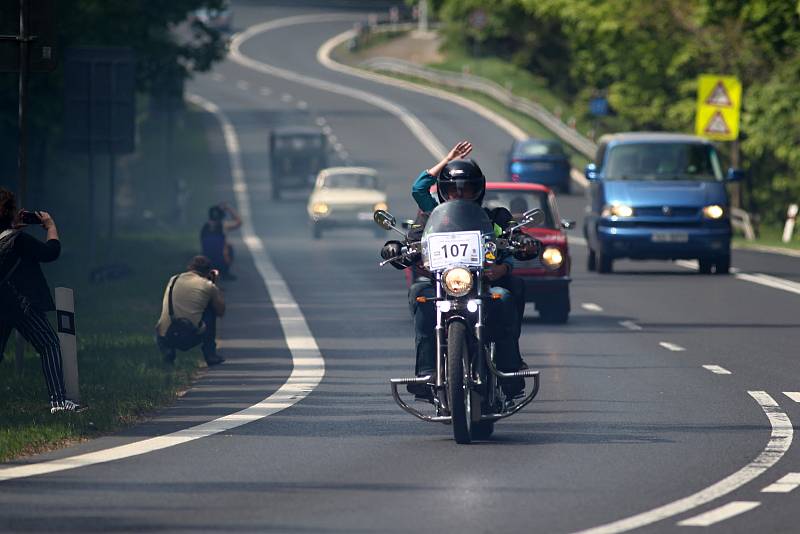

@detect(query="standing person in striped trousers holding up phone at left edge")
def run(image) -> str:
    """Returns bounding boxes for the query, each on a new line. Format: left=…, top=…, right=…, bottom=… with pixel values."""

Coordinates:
left=0, top=188, right=83, bottom=413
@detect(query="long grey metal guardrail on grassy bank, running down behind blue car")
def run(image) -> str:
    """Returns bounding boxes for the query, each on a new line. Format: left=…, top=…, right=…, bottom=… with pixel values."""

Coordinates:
left=360, top=57, right=597, bottom=159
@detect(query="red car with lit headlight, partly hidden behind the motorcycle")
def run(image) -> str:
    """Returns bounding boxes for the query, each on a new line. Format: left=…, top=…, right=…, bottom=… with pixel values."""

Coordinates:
left=483, top=182, right=575, bottom=323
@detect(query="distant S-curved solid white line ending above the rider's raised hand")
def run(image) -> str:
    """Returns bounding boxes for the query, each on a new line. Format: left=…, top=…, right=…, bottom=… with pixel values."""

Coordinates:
left=229, top=14, right=446, bottom=160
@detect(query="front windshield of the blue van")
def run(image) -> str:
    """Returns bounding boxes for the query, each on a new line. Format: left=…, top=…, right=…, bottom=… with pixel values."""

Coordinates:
left=604, top=143, right=722, bottom=182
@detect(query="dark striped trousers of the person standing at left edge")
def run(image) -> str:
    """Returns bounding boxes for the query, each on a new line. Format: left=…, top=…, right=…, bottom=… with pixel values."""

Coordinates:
left=0, top=308, right=65, bottom=403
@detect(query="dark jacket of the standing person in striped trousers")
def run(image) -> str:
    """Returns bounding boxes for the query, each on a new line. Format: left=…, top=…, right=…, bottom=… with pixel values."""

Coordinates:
left=0, top=230, right=61, bottom=312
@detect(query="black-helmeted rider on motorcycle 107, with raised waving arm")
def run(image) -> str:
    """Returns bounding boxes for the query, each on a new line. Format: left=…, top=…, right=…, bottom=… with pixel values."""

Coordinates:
left=381, top=141, right=524, bottom=397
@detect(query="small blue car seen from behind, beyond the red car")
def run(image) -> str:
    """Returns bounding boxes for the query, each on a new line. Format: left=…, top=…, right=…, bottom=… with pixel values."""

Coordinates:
left=507, top=139, right=570, bottom=193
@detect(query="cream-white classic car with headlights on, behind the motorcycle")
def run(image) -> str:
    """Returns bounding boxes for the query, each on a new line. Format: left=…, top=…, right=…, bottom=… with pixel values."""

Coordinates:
left=307, top=167, right=389, bottom=239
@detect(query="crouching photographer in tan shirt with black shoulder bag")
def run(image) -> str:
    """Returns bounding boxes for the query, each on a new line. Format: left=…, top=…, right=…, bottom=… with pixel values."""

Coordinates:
left=156, top=256, right=225, bottom=367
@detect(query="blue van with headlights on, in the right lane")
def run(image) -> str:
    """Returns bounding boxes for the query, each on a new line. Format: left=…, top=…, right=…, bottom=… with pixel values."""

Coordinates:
left=583, top=132, right=742, bottom=274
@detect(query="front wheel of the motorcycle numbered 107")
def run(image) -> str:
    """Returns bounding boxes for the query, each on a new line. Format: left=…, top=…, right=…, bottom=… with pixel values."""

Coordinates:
left=447, top=321, right=472, bottom=444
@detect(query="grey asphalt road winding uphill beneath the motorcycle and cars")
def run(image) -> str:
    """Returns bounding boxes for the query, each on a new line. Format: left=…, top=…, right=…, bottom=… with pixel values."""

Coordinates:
left=0, top=2, right=800, bottom=532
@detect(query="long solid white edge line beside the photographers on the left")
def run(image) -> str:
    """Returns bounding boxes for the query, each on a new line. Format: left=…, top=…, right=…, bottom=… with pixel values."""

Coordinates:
left=0, top=95, right=325, bottom=481
